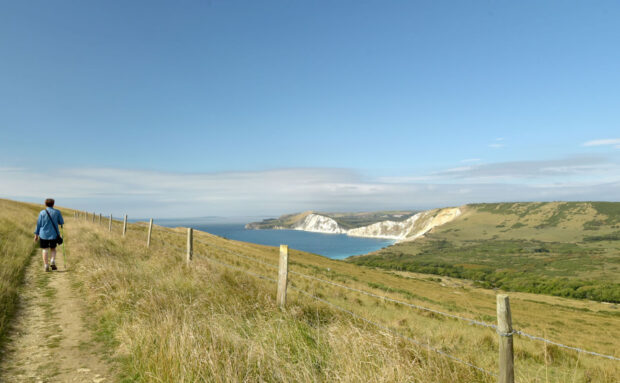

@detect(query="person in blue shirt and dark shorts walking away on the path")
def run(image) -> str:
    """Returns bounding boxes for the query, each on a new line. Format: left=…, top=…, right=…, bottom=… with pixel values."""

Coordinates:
left=34, top=198, right=65, bottom=271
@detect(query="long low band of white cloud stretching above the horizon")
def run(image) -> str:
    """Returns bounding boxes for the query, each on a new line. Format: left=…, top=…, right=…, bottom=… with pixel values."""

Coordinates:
left=0, top=157, right=620, bottom=218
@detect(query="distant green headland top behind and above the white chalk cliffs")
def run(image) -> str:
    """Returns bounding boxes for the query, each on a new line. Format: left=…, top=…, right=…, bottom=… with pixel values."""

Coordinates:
left=248, top=211, right=416, bottom=230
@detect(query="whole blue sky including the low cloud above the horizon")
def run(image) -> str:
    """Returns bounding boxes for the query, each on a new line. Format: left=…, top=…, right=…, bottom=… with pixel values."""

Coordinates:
left=0, top=0, right=620, bottom=218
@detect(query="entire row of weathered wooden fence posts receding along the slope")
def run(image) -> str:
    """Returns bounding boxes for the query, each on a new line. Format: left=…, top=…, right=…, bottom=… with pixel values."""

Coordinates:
left=70, top=211, right=514, bottom=383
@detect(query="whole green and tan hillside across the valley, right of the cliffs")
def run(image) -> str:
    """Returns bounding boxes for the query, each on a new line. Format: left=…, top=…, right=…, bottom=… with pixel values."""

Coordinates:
left=352, top=202, right=620, bottom=302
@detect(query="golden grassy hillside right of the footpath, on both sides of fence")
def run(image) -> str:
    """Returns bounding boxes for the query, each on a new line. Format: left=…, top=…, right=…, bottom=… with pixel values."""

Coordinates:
left=0, top=203, right=620, bottom=382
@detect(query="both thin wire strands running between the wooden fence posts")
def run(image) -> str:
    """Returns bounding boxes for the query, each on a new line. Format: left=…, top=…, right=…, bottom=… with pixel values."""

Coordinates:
left=77, top=213, right=620, bottom=366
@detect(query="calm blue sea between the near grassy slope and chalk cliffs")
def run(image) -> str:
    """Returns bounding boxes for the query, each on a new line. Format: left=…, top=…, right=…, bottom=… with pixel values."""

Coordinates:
left=156, top=220, right=394, bottom=259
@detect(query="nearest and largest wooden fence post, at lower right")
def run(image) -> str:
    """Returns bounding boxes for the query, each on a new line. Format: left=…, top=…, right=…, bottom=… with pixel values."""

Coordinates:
left=497, top=294, right=515, bottom=383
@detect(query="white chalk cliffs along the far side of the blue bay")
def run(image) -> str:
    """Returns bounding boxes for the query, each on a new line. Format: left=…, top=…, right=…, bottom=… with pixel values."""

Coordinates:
left=293, top=208, right=461, bottom=242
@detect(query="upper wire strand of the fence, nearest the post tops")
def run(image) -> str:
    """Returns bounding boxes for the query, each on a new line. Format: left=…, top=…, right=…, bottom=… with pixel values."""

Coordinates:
left=155, top=226, right=620, bottom=361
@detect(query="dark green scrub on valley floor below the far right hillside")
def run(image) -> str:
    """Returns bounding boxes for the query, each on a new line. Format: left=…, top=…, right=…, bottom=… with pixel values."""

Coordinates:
left=352, top=240, right=620, bottom=303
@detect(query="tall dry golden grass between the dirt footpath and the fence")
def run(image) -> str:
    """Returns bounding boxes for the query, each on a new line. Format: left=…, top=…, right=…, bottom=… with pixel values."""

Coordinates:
left=67, top=222, right=491, bottom=382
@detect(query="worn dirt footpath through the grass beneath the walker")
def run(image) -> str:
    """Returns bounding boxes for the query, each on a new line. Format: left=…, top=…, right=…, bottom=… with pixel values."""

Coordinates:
left=0, top=249, right=115, bottom=383
